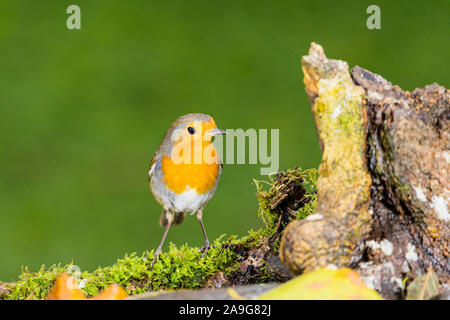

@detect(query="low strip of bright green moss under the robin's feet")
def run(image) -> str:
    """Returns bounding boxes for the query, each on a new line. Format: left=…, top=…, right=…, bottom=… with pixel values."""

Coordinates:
left=3, top=230, right=263, bottom=300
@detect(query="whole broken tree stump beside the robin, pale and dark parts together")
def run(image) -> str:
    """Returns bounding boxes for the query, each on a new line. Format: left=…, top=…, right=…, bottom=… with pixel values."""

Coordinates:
left=280, top=43, right=450, bottom=299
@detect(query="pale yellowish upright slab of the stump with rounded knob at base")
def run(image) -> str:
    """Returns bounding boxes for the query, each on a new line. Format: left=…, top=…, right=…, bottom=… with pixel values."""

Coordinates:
left=280, top=43, right=371, bottom=274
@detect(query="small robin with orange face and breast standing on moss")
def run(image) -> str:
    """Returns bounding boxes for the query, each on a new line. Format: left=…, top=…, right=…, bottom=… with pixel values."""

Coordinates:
left=148, top=113, right=226, bottom=263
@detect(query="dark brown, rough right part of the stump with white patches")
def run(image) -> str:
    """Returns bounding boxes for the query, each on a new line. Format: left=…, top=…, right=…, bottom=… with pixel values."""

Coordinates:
left=352, top=67, right=450, bottom=298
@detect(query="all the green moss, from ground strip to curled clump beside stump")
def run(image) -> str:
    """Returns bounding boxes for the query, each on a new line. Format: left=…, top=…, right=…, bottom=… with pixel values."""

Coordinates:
left=0, top=168, right=317, bottom=300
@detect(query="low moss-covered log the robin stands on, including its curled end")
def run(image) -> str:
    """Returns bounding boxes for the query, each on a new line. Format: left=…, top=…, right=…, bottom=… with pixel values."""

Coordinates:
left=0, top=168, right=317, bottom=300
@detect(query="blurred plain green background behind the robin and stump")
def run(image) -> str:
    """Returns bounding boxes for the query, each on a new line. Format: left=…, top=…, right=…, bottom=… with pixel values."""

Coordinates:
left=0, top=0, right=450, bottom=281
